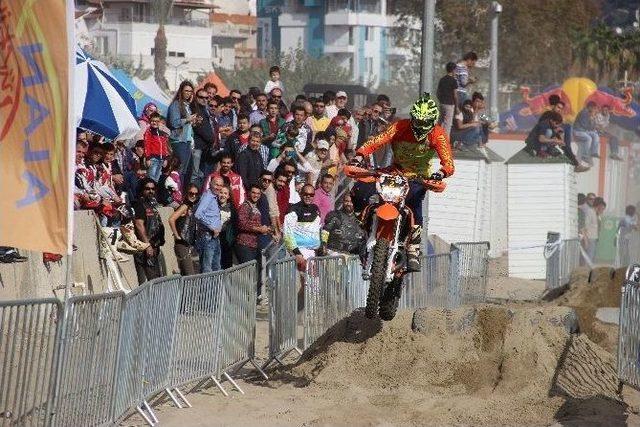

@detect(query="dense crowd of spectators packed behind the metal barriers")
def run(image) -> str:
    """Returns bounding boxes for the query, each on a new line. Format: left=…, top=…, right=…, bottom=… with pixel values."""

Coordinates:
left=74, top=67, right=395, bottom=300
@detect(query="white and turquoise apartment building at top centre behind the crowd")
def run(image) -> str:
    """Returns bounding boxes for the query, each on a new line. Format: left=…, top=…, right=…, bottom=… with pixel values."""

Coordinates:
left=257, top=0, right=419, bottom=86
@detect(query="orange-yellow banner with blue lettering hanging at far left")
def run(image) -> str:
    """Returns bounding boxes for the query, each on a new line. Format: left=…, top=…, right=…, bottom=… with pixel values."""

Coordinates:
left=0, top=0, right=75, bottom=254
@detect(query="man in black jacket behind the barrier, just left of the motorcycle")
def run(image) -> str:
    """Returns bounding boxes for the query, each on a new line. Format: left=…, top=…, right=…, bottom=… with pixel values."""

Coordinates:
left=320, top=193, right=367, bottom=257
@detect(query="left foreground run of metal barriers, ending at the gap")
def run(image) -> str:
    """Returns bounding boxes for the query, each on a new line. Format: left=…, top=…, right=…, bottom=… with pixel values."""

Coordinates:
left=0, top=261, right=266, bottom=426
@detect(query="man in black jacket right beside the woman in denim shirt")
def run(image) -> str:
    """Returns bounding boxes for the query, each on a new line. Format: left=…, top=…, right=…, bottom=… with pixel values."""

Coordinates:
left=191, top=89, right=218, bottom=187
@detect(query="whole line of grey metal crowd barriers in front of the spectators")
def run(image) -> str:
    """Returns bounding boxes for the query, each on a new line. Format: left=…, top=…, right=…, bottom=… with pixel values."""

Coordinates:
left=0, top=239, right=492, bottom=426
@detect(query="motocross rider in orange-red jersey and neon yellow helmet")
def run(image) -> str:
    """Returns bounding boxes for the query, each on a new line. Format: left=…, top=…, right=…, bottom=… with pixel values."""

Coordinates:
left=353, top=93, right=454, bottom=272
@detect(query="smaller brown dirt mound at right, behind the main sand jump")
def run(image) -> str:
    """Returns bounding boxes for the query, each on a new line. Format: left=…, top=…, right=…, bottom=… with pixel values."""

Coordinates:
left=553, top=267, right=625, bottom=352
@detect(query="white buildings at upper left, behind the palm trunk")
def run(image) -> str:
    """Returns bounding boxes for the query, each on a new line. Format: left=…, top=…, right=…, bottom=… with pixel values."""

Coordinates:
left=77, top=0, right=257, bottom=90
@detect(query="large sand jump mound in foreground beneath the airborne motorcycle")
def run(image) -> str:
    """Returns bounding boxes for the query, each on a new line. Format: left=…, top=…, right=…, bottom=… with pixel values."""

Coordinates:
left=288, top=306, right=623, bottom=424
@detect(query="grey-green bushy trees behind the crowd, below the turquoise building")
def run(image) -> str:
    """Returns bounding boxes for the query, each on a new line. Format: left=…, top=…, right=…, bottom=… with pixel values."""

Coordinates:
left=216, top=47, right=356, bottom=99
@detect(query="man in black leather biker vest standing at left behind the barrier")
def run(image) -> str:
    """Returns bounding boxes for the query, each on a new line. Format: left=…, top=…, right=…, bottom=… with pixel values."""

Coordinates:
left=133, top=178, right=164, bottom=285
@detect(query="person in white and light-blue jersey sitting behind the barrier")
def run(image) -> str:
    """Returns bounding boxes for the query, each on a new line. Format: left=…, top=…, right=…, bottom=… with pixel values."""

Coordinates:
left=284, top=184, right=320, bottom=272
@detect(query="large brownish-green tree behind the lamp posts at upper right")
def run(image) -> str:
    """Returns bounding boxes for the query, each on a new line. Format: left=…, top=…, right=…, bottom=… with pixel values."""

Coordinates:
left=390, top=0, right=600, bottom=86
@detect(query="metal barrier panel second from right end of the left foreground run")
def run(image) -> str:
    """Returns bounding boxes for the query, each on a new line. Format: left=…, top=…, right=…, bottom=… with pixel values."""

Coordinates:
left=171, top=271, right=226, bottom=396
